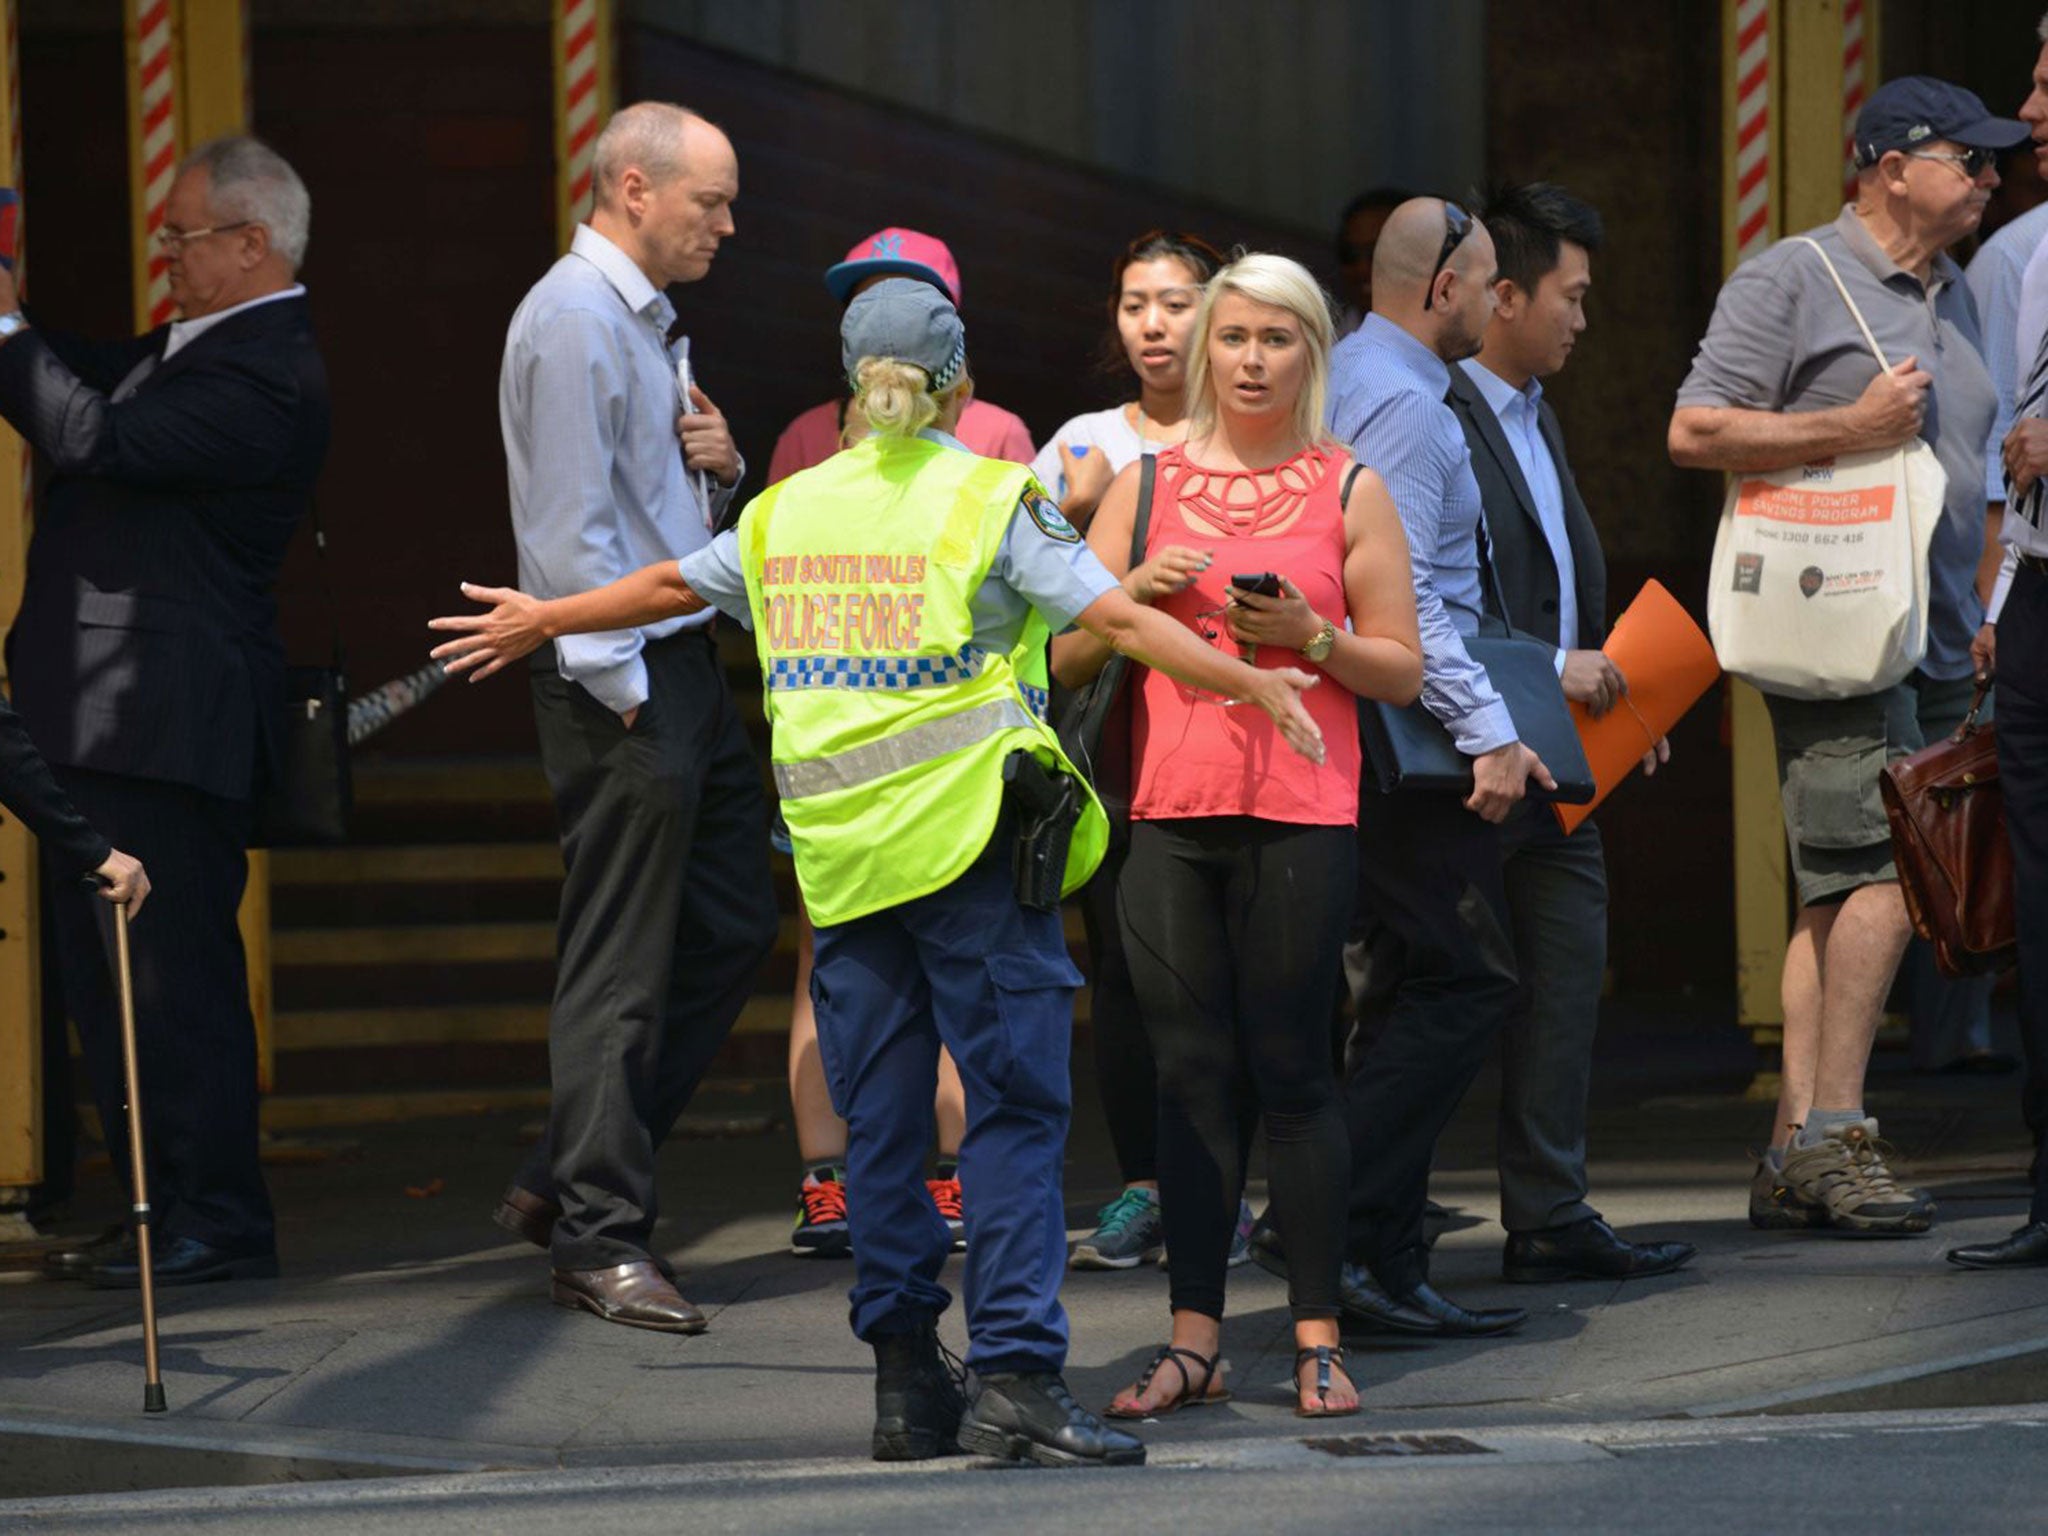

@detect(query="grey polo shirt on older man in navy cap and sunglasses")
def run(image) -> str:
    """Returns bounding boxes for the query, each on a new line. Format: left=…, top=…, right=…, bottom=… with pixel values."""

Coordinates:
left=1677, top=207, right=1999, bottom=680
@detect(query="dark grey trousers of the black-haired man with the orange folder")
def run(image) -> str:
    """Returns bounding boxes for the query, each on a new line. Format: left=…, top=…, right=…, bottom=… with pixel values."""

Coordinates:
left=1499, top=805, right=1608, bottom=1233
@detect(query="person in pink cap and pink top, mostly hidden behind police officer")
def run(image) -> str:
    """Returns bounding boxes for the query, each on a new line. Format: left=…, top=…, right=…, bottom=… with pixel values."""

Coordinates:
left=768, top=227, right=1032, bottom=1257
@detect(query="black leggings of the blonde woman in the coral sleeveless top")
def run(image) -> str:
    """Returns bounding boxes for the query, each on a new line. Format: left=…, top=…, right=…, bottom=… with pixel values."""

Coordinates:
left=1116, top=817, right=1358, bottom=1319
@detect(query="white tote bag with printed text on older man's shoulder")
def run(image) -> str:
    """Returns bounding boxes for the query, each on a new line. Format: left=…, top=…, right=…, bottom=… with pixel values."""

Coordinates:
left=1706, top=238, right=1948, bottom=698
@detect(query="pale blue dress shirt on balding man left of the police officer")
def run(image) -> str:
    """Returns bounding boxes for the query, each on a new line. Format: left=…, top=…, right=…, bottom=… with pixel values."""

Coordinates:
left=498, top=225, right=737, bottom=715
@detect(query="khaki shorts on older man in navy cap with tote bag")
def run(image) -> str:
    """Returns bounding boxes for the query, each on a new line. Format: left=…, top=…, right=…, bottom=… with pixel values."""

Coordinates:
left=1763, top=682, right=1925, bottom=907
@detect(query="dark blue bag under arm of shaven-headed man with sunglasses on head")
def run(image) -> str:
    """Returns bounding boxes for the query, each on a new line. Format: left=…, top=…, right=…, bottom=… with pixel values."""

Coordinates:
left=1358, top=505, right=1597, bottom=805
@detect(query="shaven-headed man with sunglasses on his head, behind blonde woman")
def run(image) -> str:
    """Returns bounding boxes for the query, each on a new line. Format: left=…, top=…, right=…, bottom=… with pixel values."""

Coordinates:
left=1329, top=197, right=1552, bottom=1335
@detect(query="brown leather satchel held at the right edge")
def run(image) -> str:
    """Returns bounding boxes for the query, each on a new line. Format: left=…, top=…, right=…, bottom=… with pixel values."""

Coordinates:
left=1878, top=684, right=2017, bottom=977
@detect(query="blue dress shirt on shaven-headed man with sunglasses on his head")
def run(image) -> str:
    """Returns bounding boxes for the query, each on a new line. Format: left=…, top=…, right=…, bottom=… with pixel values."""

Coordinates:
left=1329, top=315, right=1516, bottom=758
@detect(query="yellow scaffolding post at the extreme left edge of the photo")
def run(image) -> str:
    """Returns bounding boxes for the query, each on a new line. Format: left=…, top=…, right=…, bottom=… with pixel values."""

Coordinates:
left=0, top=0, right=43, bottom=1212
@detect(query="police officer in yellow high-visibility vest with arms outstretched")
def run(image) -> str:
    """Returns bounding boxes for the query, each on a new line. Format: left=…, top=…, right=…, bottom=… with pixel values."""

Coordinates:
left=432, top=281, right=1323, bottom=1464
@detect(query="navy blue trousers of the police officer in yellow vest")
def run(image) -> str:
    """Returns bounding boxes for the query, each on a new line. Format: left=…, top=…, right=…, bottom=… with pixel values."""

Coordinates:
left=811, top=860, right=1081, bottom=1372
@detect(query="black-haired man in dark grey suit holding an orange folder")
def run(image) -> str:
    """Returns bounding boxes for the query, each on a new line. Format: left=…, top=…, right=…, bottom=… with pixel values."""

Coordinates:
left=1448, top=182, right=1694, bottom=1280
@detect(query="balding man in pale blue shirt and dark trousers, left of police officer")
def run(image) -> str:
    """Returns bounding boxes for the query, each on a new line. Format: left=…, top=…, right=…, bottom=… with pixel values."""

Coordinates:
left=496, top=102, right=776, bottom=1333
